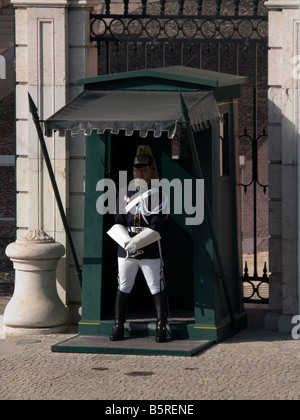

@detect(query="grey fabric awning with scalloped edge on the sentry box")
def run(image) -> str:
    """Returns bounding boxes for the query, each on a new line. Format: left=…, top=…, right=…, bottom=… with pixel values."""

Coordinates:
left=45, top=90, right=220, bottom=138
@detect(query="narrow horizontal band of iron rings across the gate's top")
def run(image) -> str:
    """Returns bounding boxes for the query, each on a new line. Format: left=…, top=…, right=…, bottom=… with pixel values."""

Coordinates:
left=91, top=14, right=268, bottom=43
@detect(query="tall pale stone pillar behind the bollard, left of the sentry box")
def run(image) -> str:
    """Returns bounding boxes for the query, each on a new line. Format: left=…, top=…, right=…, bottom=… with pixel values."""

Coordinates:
left=12, top=0, right=98, bottom=321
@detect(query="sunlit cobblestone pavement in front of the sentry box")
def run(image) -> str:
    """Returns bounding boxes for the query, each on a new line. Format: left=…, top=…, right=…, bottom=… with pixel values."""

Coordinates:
left=0, top=310, right=300, bottom=401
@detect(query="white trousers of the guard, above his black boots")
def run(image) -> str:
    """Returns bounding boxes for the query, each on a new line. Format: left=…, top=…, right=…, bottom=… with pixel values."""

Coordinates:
left=118, top=257, right=164, bottom=295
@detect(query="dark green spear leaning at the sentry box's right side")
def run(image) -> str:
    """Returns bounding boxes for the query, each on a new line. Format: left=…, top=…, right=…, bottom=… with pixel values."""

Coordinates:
left=180, top=94, right=235, bottom=328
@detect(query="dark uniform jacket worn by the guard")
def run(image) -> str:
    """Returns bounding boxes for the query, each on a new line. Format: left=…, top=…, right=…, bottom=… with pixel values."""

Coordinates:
left=115, top=188, right=168, bottom=259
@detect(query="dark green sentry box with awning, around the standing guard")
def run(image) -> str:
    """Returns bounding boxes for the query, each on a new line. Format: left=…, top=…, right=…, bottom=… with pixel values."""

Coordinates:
left=46, top=66, right=246, bottom=352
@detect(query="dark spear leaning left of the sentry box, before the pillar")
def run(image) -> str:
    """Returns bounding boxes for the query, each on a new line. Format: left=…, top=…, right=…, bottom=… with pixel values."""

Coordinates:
left=28, top=93, right=82, bottom=286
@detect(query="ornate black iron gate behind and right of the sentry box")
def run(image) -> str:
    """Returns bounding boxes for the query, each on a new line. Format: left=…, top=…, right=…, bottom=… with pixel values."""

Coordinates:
left=91, top=0, right=268, bottom=302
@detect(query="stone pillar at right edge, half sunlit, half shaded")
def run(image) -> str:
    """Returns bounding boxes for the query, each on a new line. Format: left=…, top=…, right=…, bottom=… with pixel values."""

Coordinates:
left=265, top=0, right=299, bottom=331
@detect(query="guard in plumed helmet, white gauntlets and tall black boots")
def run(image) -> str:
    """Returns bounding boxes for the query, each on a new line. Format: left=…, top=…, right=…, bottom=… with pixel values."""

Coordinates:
left=108, top=146, right=168, bottom=342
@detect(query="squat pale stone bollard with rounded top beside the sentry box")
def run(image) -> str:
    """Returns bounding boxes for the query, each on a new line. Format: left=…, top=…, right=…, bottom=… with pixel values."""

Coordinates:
left=3, top=230, right=68, bottom=334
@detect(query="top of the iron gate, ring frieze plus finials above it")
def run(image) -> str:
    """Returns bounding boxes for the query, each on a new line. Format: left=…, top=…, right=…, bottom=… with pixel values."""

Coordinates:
left=91, top=0, right=268, bottom=44
